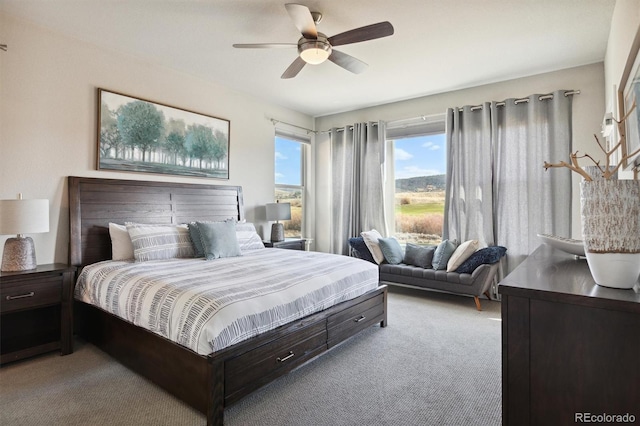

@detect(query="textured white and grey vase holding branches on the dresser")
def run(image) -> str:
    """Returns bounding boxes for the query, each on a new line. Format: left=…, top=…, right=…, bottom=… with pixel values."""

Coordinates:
left=580, top=179, right=640, bottom=289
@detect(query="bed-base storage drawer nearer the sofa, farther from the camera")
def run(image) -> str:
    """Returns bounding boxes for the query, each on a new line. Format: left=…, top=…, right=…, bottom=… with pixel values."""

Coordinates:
left=327, top=294, right=384, bottom=348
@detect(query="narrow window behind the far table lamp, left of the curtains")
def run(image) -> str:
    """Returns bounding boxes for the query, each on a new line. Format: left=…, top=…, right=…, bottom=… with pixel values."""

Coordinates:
left=275, top=132, right=309, bottom=238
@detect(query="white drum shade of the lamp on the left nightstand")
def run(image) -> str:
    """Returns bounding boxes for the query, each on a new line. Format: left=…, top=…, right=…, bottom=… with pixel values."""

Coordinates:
left=0, top=200, right=49, bottom=235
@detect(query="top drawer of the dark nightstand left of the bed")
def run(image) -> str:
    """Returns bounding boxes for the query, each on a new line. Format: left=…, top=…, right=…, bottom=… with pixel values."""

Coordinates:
left=0, top=276, right=62, bottom=313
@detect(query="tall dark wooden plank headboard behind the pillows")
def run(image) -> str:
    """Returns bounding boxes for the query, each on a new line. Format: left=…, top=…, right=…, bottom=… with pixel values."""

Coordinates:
left=68, top=176, right=244, bottom=266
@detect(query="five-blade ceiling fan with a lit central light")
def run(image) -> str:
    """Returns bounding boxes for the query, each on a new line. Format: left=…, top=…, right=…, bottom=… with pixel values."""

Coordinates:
left=233, top=3, right=393, bottom=78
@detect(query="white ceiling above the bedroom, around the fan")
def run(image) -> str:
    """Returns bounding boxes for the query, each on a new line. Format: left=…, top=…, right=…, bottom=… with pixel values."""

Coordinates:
left=0, top=0, right=615, bottom=116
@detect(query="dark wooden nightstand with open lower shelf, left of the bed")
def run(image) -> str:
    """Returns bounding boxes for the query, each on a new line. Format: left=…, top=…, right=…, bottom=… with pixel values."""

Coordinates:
left=0, top=263, right=76, bottom=364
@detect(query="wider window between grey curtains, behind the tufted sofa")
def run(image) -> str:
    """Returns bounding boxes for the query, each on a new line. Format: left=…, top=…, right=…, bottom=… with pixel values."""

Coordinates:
left=387, top=116, right=447, bottom=245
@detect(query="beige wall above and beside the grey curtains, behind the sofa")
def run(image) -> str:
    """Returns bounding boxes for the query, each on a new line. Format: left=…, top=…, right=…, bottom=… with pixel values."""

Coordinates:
left=316, top=63, right=604, bottom=250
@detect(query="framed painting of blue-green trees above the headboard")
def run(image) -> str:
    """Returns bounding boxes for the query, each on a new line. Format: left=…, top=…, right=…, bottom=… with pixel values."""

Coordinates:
left=97, top=88, right=231, bottom=179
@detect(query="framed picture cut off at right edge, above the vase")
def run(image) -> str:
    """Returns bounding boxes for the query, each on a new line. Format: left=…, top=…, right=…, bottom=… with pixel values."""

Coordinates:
left=618, top=31, right=640, bottom=171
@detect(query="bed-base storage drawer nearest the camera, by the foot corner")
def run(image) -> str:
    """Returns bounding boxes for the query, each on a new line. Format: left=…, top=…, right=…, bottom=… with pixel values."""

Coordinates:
left=224, top=321, right=327, bottom=404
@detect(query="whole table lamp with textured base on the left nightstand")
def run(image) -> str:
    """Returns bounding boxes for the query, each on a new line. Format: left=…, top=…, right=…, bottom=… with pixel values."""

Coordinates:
left=0, top=194, right=49, bottom=272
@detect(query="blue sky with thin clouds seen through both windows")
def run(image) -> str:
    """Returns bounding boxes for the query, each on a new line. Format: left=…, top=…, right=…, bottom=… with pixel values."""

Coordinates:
left=275, top=134, right=446, bottom=185
